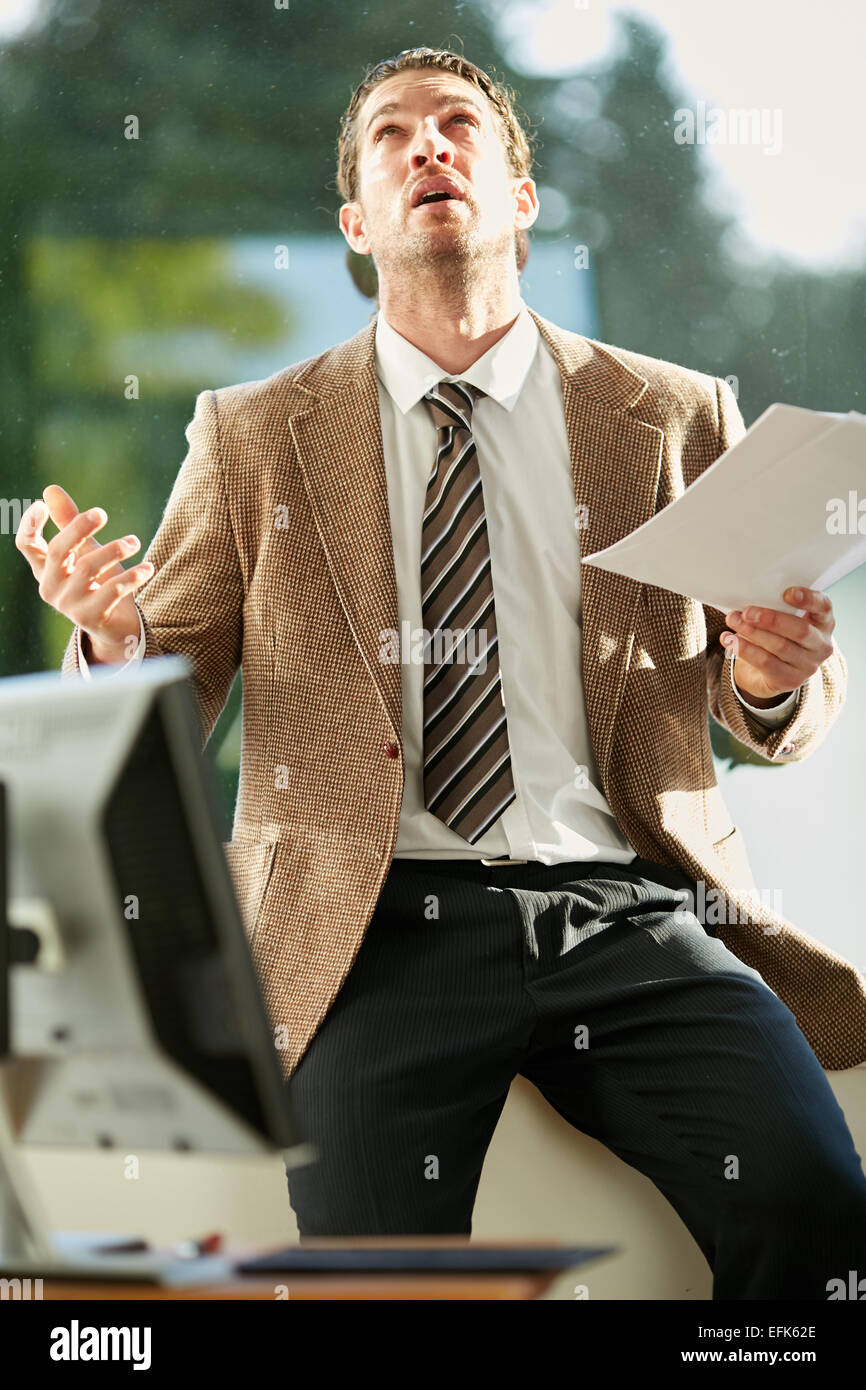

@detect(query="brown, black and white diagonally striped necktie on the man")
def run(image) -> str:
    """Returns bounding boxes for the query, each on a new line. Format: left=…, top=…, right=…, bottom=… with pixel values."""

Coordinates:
left=421, top=381, right=516, bottom=845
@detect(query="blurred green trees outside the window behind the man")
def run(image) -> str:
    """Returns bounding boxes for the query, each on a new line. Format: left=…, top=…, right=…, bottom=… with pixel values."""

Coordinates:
left=0, top=0, right=866, bottom=828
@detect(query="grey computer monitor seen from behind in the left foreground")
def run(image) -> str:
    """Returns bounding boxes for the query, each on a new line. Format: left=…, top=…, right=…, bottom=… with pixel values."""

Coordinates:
left=0, top=656, right=314, bottom=1277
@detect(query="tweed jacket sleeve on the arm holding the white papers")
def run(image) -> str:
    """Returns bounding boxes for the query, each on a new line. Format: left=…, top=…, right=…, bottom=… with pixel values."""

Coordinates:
left=703, top=377, right=848, bottom=763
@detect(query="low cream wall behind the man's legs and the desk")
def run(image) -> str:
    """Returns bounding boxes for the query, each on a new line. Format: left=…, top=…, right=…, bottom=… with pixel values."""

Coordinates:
left=26, top=1066, right=866, bottom=1300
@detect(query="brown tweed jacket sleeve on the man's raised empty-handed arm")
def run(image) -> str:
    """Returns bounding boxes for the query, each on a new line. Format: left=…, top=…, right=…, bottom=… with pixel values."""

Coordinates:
left=61, top=391, right=245, bottom=746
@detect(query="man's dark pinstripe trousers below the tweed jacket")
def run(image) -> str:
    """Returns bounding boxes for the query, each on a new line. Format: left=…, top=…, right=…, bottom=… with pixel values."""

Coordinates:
left=288, top=859, right=866, bottom=1300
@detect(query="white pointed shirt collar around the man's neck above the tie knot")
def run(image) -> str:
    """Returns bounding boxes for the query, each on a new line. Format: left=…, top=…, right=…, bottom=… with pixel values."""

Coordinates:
left=375, top=302, right=539, bottom=414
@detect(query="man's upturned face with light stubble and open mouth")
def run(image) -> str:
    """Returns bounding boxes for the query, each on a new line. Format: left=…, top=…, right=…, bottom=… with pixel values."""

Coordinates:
left=341, top=70, right=538, bottom=278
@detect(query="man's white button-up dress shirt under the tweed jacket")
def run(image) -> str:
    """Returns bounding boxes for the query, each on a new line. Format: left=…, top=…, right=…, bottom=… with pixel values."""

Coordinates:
left=79, top=304, right=798, bottom=863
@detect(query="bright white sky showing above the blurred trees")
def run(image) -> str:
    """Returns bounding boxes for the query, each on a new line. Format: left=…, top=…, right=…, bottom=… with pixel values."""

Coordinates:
left=0, top=0, right=866, bottom=265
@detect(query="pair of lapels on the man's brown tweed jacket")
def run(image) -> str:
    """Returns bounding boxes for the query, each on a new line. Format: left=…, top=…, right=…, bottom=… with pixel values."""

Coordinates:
left=289, top=310, right=664, bottom=781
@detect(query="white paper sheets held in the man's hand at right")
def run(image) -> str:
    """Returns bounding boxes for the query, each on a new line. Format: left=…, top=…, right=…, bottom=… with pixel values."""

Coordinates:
left=584, top=404, right=866, bottom=613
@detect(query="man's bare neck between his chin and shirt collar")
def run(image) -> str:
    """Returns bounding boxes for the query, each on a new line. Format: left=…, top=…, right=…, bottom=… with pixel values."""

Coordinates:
left=379, top=265, right=523, bottom=375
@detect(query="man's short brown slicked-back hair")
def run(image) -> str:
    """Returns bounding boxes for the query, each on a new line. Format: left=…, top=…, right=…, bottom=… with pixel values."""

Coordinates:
left=336, top=49, right=532, bottom=271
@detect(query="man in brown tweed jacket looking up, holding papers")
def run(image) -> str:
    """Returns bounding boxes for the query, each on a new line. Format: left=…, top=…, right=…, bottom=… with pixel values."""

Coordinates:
left=19, top=50, right=866, bottom=1298
